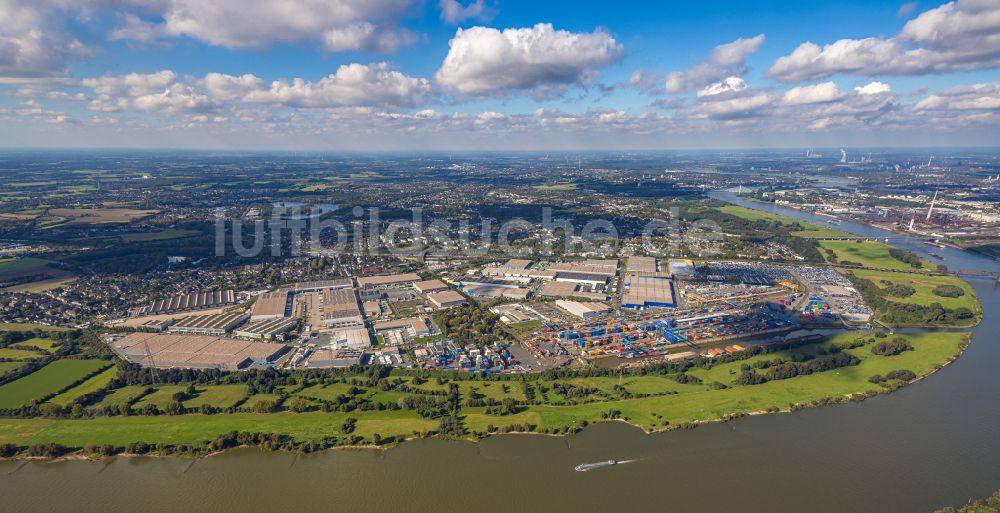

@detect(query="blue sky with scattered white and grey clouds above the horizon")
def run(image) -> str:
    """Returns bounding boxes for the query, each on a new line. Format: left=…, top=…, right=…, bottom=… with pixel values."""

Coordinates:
left=0, top=0, right=1000, bottom=150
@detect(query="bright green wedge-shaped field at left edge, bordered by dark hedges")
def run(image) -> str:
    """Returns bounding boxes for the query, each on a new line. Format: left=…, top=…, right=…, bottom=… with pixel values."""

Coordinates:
left=0, top=359, right=111, bottom=408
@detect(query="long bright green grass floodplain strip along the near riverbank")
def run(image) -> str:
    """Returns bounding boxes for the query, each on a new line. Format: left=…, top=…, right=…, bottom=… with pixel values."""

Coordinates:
left=0, top=333, right=968, bottom=447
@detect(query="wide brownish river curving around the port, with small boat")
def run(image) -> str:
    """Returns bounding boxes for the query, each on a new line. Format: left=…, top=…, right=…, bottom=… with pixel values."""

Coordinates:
left=0, top=193, right=1000, bottom=513
